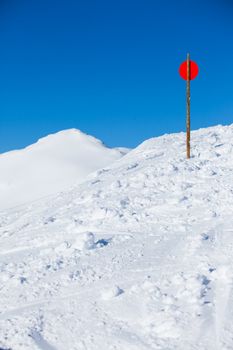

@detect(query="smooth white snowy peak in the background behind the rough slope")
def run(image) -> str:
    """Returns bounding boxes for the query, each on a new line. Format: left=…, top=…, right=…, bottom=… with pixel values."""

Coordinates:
left=0, top=129, right=127, bottom=210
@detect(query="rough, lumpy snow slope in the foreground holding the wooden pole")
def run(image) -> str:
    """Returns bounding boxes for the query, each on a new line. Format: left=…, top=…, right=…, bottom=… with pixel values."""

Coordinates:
left=0, top=125, right=233, bottom=350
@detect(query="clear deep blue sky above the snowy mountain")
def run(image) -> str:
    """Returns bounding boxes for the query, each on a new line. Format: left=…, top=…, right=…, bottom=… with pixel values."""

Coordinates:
left=0, top=0, right=233, bottom=152
